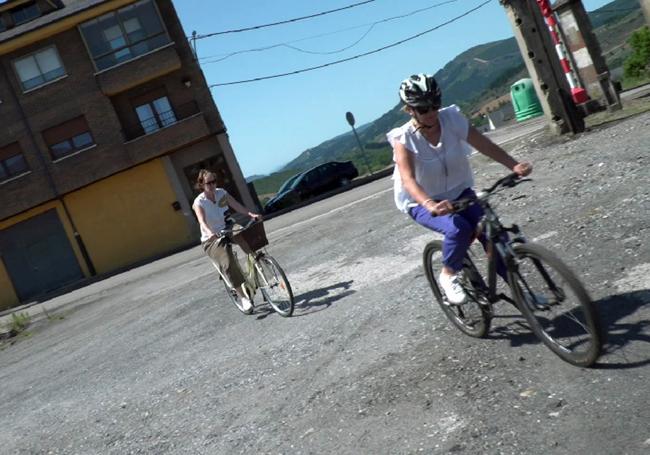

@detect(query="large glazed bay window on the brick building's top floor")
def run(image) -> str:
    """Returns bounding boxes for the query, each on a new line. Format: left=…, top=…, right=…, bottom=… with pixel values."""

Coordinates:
left=81, top=0, right=170, bottom=70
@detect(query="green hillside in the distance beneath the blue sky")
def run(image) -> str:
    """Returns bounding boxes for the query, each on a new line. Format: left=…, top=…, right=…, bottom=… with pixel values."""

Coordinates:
left=253, top=0, right=644, bottom=199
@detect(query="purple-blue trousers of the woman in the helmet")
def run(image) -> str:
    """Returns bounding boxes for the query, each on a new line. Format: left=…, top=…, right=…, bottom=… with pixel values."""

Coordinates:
left=409, top=188, right=506, bottom=277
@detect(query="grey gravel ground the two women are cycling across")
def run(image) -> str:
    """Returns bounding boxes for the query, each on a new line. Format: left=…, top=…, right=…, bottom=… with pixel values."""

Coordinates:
left=0, top=114, right=650, bottom=454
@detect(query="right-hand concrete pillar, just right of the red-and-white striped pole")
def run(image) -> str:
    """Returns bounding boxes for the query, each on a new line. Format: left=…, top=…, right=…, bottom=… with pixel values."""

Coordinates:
left=553, top=0, right=620, bottom=114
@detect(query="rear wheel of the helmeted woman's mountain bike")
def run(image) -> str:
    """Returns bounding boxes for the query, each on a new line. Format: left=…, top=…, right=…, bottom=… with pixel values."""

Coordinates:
left=423, top=240, right=492, bottom=338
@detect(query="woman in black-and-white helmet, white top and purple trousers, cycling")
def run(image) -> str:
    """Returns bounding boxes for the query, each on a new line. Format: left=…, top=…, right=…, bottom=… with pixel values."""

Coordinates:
left=386, top=74, right=532, bottom=304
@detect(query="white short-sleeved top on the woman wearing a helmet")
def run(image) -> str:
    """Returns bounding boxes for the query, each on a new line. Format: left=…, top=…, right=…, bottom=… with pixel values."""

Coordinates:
left=386, top=104, right=474, bottom=213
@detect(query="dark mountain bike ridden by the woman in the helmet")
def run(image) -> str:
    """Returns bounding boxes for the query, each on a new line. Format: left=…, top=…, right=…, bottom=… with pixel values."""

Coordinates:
left=423, top=174, right=602, bottom=367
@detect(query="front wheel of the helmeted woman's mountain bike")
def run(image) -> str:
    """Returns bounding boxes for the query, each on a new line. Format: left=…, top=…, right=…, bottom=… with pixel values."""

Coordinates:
left=508, top=243, right=603, bottom=367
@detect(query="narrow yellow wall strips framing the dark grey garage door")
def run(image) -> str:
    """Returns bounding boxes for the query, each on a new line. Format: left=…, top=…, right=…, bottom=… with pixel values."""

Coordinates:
left=0, top=201, right=90, bottom=310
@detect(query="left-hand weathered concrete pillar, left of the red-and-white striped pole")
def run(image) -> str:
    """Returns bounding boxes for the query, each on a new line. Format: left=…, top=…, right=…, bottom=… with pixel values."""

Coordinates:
left=500, top=0, right=585, bottom=134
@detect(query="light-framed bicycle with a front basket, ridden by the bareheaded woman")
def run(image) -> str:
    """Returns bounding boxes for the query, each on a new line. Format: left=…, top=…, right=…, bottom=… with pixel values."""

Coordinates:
left=213, top=220, right=294, bottom=317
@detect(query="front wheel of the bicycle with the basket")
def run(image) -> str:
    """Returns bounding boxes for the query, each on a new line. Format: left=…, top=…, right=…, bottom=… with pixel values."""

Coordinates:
left=255, top=254, right=295, bottom=318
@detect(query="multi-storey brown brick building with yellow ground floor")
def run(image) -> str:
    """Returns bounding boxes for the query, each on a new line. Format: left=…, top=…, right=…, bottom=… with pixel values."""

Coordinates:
left=0, top=0, right=254, bottom=309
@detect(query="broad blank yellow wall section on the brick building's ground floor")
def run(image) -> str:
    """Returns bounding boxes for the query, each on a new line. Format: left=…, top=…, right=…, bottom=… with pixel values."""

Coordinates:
left=65, top=160, right=193, bottom=274
